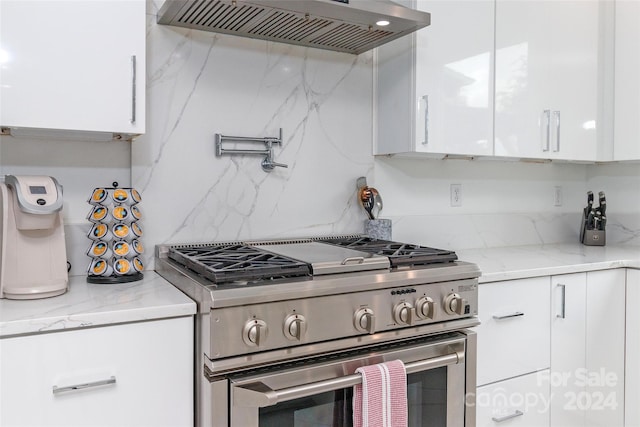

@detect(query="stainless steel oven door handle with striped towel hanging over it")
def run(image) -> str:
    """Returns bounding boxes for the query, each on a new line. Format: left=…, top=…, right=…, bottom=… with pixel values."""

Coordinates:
left=233, top=351, right=465, bottom=408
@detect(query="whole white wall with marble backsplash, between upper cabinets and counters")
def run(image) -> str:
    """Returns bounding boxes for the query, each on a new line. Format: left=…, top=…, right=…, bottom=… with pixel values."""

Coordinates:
left=0, top=0, right=640, bottom=274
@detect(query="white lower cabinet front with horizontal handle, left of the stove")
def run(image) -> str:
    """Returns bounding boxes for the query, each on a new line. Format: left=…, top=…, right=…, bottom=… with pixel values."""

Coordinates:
left=0, top=317, right=193, bottom=427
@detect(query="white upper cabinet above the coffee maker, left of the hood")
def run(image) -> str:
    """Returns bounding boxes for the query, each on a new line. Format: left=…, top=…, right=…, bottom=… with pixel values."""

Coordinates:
left=0, top=0, right=146, bottom=134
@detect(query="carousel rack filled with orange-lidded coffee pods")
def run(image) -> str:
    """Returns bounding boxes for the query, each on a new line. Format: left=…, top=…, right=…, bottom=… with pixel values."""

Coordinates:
left=87, top=182, right=144, bottom=284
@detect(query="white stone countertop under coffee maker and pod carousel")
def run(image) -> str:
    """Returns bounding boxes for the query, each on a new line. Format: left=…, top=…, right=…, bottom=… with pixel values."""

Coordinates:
left=0, top=271, right=196, bottom=338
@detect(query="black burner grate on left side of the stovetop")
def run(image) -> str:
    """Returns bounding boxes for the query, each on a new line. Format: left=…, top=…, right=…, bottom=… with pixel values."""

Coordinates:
left=168, top=244, right=311, bottom=284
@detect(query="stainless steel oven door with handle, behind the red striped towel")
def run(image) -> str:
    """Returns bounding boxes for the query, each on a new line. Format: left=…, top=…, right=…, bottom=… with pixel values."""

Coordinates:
left=229, top=331, right=475, bottom=427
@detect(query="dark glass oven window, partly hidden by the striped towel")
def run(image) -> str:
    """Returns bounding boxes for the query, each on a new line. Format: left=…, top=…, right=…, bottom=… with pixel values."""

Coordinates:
left=259, top=367, right=447, bottom=427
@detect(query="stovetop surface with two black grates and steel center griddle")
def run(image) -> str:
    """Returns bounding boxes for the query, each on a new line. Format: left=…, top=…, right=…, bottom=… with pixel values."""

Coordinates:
left=162, top=235, right=457, bottom=284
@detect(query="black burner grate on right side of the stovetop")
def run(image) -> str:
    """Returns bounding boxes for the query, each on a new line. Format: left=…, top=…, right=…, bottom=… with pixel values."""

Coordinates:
left=319, top=236, right=458, bottom=267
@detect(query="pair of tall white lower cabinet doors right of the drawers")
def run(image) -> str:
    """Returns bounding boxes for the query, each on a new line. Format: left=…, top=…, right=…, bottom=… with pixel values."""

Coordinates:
left=551, top=269, right=625, bottom=427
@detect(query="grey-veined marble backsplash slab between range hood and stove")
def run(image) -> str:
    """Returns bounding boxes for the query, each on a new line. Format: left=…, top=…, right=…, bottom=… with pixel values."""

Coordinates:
left=132, top=4, right=374, bottom=268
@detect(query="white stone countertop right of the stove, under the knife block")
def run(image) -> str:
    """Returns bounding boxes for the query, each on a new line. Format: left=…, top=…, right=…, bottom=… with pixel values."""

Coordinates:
left=456, top=243, right=640, bottom=283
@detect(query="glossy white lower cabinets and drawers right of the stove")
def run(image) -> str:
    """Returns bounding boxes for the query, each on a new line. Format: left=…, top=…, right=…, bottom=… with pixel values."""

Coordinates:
left=477, top=269, right=624, bottom=427
